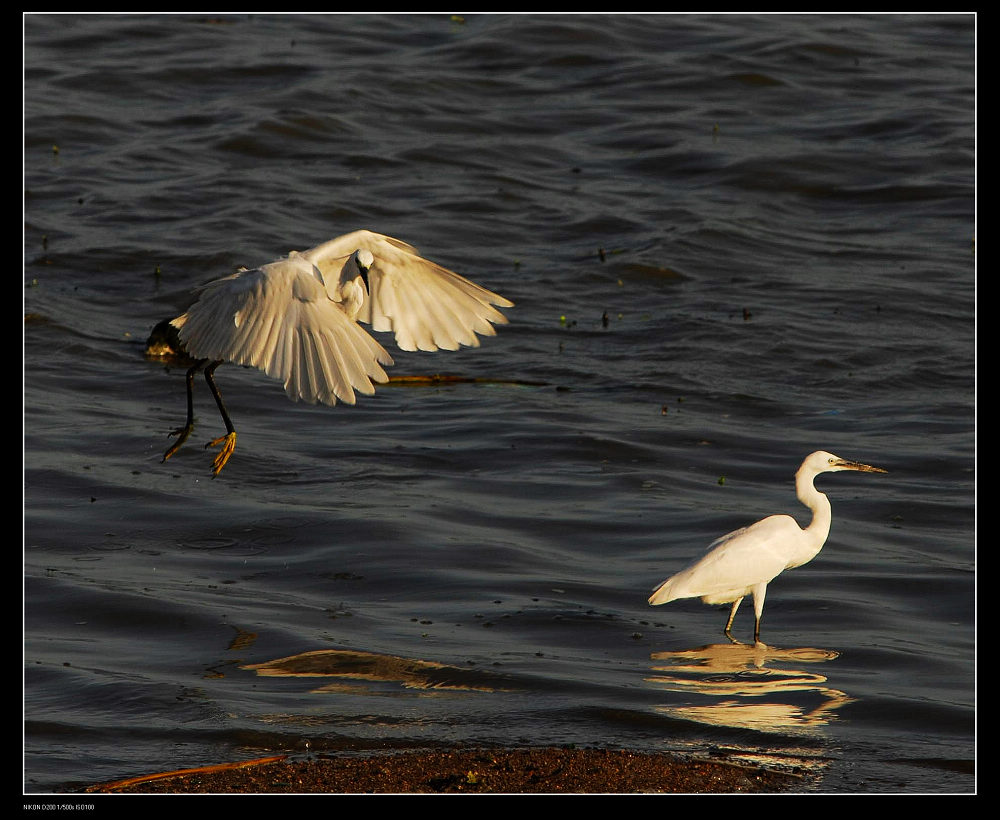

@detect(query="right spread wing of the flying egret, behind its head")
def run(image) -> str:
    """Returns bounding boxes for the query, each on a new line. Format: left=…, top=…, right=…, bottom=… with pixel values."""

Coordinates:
left=302, top=231, right=513, bottom=351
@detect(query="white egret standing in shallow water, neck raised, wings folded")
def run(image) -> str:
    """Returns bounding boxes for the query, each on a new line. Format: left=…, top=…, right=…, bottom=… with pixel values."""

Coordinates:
left=649, top=450, right=886, bottom=643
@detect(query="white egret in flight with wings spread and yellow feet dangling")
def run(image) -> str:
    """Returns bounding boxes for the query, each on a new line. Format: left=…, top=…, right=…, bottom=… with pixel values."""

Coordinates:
left=163, top=230, right=513, bottom=477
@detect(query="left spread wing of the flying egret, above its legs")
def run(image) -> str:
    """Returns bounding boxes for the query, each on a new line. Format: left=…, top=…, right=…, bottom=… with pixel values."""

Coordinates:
left=173, top=253, right=392, bottom=405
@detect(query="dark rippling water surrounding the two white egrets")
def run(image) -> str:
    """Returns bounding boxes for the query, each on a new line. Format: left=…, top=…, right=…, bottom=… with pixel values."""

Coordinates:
left=24, top=15, right=976, bottom=792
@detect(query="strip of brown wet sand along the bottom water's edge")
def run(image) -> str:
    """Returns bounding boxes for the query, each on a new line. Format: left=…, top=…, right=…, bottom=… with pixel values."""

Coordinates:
left=87, top=748, right=807, bottom=794
